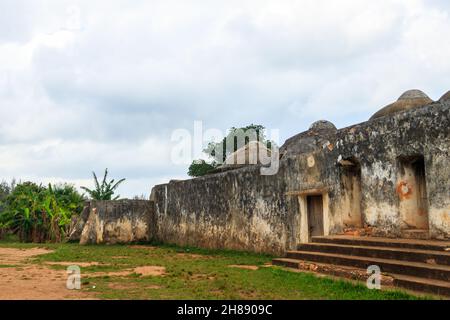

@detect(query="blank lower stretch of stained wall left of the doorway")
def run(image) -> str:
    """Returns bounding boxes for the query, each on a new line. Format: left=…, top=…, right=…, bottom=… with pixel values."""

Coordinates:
left=151, top=167, right=293, bottom=252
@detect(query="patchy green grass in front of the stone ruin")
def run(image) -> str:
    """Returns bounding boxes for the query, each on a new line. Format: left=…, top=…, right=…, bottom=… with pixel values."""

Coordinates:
left=0, top=242, right=430, bottom=300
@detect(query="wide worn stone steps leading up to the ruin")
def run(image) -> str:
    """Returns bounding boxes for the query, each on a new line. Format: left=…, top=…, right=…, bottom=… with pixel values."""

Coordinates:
left=273, top=236, right=450, bottom=297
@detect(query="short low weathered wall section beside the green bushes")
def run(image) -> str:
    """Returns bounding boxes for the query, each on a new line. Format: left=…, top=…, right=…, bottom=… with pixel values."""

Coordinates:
left=70, top=200, right=154, bottom=244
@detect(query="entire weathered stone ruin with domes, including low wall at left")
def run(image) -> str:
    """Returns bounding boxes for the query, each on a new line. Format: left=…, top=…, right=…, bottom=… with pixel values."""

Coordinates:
left=71, top=90, right=450, bottom=254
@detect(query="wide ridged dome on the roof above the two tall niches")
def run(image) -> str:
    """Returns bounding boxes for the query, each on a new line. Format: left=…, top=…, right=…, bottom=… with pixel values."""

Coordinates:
left=370, top=90, right=433, bottom=120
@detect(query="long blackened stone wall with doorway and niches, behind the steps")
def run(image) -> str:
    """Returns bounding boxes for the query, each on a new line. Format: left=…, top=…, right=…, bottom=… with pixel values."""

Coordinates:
left=151, top=103, right=450, bottom=253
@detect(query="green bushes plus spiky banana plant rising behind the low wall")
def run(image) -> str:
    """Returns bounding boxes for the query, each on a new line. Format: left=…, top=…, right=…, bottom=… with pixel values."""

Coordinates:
left=0, top=169, right=125, bottom=243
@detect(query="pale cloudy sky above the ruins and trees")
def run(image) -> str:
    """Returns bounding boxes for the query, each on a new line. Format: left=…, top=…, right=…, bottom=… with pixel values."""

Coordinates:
left=0, top=0, right=450, bottom=197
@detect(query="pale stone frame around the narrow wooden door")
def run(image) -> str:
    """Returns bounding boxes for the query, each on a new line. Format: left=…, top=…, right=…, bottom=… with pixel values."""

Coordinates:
left=297, top=189, right=330, bottom=243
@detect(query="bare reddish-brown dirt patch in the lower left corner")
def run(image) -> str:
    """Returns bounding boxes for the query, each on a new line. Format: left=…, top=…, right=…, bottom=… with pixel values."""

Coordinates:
left=0, top=248, right=93, bottom=300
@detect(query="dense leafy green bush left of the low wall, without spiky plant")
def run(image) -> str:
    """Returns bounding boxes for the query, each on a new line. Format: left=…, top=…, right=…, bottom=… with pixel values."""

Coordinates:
left=0, top=182, right=84, bottom=242
